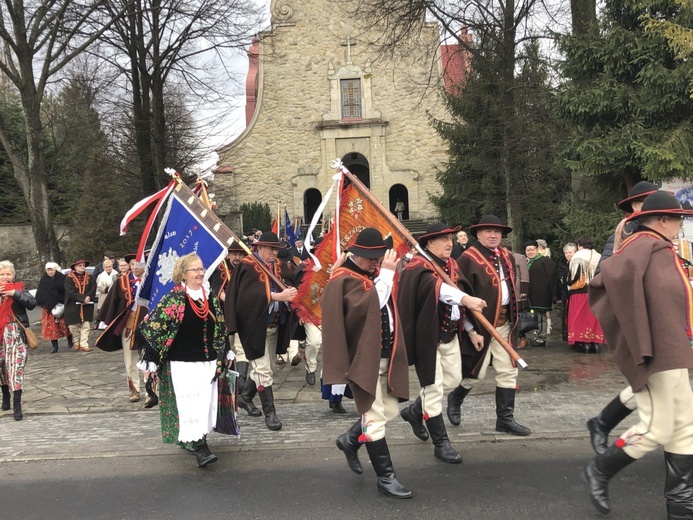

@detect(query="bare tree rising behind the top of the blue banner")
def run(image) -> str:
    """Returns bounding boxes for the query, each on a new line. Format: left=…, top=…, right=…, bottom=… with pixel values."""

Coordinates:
left=100, top=0, right=262, bottom=193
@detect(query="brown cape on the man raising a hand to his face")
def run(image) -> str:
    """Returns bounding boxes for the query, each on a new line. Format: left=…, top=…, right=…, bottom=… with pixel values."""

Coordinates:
left=320, top=267, right=409, bottom=414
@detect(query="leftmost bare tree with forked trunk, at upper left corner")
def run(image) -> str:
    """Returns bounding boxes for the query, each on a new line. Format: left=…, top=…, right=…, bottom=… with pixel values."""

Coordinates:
left=0, top=0, right=120, bottom=261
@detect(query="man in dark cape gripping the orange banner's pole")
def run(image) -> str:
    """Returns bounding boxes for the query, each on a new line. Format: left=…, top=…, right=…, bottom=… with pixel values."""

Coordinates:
left=397, top=222, right=486, bottom=464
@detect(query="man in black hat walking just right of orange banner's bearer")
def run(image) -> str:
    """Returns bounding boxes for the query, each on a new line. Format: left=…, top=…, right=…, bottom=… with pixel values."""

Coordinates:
left=448, top=215, right=531, bottom=436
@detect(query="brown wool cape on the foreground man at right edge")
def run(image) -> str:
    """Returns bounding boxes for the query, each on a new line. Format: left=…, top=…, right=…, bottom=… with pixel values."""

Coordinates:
left=589, top=231, right=693, bottom=392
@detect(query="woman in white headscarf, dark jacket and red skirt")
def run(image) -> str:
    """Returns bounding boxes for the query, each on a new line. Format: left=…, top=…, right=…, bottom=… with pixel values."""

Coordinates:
left=36, top=262, right=72, bottom=354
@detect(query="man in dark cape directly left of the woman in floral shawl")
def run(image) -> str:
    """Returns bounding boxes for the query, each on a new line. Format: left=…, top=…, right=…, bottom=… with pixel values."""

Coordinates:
left=96, top=254, right=149, bottom=408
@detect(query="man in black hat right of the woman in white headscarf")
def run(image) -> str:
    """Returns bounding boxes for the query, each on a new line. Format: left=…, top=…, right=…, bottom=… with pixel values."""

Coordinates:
left=64, top=259, right=96, bottom=352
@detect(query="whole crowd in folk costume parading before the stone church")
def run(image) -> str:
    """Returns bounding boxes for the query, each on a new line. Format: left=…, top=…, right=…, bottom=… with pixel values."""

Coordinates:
left=5, top=182, right=693, bottom=519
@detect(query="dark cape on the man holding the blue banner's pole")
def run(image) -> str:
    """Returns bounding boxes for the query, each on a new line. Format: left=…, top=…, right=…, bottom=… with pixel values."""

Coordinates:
left=224, top=257, right=293, bottom=361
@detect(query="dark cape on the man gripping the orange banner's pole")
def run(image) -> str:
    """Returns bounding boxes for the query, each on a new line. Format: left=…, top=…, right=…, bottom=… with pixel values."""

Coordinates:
left=397, top=254, right=470, bottom=387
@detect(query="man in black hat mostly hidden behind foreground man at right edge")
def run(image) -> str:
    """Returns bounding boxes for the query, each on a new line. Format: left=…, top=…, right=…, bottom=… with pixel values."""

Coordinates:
left=587, top=181, right=658, bottom=454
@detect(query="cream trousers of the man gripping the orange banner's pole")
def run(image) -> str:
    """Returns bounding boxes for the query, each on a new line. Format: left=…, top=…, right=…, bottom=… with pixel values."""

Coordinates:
left=419, top=336, right=462, bottom=417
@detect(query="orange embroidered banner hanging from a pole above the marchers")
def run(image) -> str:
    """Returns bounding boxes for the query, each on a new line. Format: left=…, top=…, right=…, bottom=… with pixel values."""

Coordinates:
left=292, top=184, right=410, bottom=325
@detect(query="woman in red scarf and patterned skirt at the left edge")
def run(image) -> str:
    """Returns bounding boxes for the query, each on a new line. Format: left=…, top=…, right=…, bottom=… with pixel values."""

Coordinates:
left=0, top=260, right=36, bottom=421
